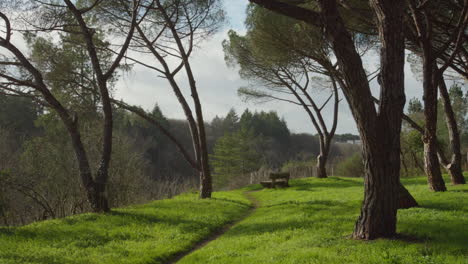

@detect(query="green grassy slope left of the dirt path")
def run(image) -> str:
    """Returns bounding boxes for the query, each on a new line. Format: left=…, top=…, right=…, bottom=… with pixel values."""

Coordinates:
left=0, top=191, right=250, bottom=264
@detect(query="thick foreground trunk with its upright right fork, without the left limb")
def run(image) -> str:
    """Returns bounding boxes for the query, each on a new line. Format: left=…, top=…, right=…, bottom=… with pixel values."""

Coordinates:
left=352, top=0, right=407, bottom=239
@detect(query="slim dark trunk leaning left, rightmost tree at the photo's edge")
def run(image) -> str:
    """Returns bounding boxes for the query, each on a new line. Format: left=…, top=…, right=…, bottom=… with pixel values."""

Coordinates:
left=439, top=74, right=466, bottom=185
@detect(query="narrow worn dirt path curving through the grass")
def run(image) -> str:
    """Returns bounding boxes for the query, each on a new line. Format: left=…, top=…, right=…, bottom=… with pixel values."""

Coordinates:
left=166, top=191, right=260, bottom=264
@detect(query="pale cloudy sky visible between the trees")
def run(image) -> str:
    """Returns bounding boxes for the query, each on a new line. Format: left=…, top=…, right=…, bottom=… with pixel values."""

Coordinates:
left=115, top=0, right=430, bottom=134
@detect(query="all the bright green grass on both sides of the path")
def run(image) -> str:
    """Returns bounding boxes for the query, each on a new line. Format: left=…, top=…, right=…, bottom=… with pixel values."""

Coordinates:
left=0, top=177, right=468, bottom=264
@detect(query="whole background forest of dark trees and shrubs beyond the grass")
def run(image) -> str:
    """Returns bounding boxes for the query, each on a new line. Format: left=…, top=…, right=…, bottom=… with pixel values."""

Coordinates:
left=0, top=85, right=468, bottom=225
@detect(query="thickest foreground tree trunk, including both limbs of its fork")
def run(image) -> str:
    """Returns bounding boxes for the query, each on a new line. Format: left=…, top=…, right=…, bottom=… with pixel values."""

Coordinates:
left=320, top=0, right=405, bottom=240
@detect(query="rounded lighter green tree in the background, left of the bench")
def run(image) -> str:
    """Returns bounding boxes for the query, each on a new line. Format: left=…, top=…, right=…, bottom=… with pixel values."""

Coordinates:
left=211, top=129, right=261, bottom=188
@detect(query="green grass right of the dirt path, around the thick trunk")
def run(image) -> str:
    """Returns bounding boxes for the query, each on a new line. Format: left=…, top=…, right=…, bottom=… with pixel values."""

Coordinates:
left=180, top=175, right=468, bottom=264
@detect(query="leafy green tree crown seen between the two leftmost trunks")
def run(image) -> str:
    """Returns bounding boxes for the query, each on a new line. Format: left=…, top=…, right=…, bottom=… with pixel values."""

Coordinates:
left=26, top=10, right=118, bottom=115
